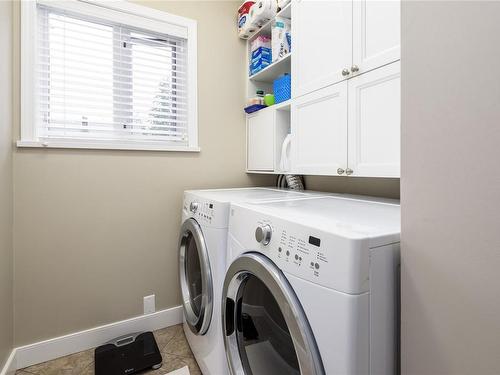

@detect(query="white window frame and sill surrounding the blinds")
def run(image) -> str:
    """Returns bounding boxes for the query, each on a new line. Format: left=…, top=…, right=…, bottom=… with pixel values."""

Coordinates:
left=17, top=0, right=200, bottom=152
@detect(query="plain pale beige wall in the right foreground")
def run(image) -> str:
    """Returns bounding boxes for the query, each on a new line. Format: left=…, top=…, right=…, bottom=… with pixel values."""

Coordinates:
left=401, top=1, right=500, bottom=375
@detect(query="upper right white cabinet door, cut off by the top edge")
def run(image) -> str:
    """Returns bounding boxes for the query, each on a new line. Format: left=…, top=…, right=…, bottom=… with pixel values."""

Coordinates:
left=353, top=0, right=401, bottom=74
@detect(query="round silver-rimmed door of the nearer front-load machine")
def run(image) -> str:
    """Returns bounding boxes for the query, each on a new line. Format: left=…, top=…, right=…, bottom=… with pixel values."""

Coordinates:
left=222, top=253, right=325, bottom=375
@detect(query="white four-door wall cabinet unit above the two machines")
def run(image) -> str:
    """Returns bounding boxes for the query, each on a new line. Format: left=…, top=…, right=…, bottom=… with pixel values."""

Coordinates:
left=244, top=0, right=401, bottom=178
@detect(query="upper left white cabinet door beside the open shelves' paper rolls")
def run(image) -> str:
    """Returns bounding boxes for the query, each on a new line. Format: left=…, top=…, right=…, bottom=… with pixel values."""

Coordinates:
left=292, top=0, right=352, bottom=97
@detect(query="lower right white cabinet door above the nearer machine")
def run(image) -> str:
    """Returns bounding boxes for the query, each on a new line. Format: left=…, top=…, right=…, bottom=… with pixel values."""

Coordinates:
left=348, top=61, right=401, bottom=177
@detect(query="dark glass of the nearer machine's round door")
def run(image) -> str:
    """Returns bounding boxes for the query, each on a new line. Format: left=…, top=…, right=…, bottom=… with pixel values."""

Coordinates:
left=236, top=275, right=300, bottom=375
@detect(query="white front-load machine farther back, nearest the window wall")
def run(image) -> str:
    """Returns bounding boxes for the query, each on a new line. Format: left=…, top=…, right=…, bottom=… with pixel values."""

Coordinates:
left=179, top=188, right=322, bottom=375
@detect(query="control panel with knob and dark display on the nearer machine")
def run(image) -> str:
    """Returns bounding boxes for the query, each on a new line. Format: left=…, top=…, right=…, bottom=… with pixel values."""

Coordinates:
left=229, top=205, right=369, bottom=294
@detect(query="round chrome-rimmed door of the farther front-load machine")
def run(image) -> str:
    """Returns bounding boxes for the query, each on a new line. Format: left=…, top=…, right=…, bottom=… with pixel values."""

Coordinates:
left=179, top=218, right=213, bottom=335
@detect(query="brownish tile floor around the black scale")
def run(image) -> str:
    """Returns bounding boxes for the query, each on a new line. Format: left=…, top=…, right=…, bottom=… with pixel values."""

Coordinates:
left=16, top=324, right=201, bottom=375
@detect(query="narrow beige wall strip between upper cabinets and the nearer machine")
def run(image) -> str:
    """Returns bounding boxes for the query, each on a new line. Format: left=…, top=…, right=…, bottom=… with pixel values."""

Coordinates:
left=305, top=176, right=399, bottom=199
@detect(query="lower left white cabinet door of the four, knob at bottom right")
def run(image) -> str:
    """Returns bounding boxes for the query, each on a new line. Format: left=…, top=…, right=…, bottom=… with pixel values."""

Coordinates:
left=291, top=81, right=347, bottom=175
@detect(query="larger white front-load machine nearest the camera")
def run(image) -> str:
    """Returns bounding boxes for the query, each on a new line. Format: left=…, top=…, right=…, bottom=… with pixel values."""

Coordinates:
left=222, top=196, right=400, bottom=375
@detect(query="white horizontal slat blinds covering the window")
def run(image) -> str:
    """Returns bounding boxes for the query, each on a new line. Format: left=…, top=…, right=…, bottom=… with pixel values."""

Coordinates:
left=35, top=5, right=189, bottom=146
